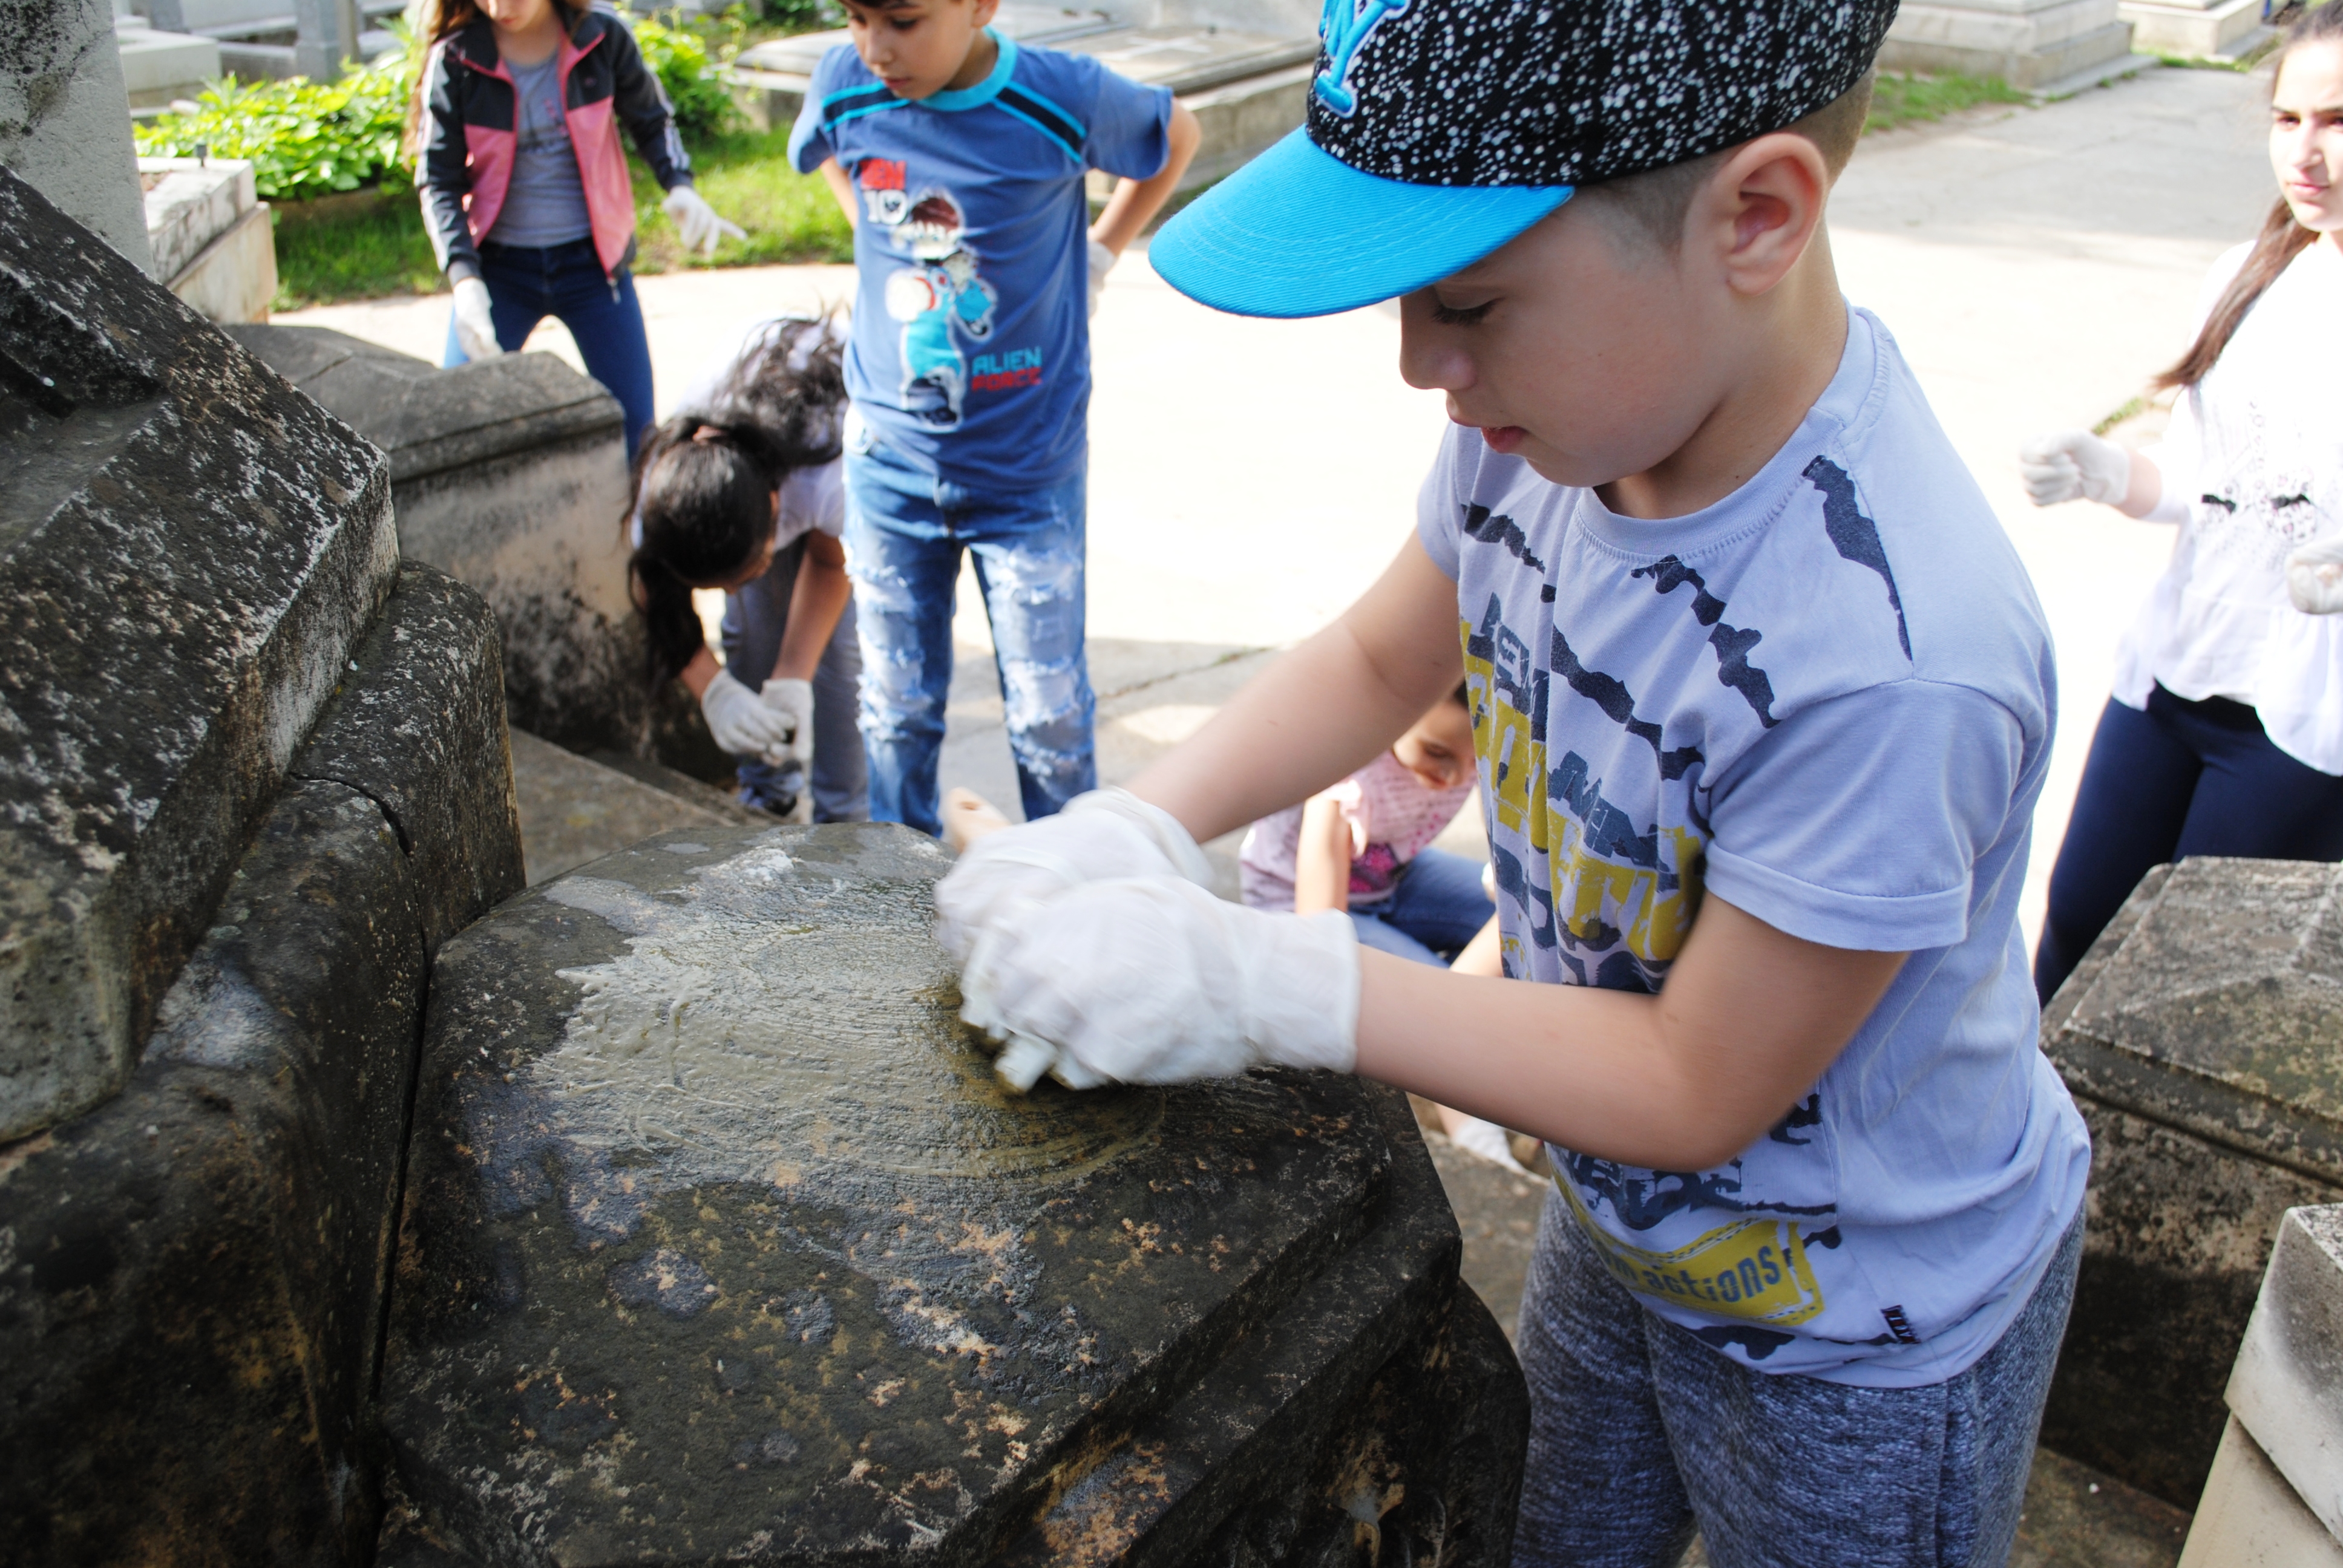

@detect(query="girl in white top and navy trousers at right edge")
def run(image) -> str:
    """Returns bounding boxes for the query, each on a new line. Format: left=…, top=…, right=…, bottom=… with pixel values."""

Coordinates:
left=2020, top=5, right=2343, bottom=1001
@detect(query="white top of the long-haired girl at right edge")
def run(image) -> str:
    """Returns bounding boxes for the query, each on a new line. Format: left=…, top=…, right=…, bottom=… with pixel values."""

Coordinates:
left=2114, top=239, right=2343, bottom=774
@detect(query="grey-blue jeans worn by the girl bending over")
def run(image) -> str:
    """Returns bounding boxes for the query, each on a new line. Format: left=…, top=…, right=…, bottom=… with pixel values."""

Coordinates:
left=724, top=539, right=871, bottom=823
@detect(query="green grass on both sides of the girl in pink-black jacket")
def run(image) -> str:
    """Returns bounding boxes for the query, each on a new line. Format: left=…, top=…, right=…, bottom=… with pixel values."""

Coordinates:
left=272, top=131, right=853, bottom=309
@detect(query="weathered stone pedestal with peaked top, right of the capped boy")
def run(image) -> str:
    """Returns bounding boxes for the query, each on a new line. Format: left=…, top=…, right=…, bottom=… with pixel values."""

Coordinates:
left=2043, top=860, right=2343, bottom=1507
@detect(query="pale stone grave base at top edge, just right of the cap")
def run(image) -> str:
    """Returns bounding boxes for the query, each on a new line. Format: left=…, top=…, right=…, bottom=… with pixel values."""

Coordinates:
left=1879, top=0, right=2155, bottom=94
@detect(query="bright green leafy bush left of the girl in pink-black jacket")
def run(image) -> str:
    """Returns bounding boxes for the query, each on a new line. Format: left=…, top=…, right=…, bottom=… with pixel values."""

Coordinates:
left=134, top=54, right=415, bottom=201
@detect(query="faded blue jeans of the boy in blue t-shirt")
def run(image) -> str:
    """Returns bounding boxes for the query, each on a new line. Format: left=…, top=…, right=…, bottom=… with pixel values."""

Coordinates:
left=846, top=439, right=1099, bottom=834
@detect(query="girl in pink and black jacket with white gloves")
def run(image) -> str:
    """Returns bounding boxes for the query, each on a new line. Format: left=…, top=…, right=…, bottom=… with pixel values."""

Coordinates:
left=408, top=0, right=741, bottom=459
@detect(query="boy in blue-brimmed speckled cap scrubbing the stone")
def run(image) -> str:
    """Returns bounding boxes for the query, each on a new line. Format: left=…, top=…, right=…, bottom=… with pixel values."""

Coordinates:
left=937, top=0, right=2090, bottom=1568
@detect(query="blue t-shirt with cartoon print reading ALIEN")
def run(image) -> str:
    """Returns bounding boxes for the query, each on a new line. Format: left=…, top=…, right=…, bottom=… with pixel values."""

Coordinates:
left=790, top=33, right=1172, bottom=492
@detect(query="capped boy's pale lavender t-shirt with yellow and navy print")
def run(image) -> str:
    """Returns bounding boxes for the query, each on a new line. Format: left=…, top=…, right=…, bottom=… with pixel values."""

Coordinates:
left=1418, top=309, right=2090, bottom=1388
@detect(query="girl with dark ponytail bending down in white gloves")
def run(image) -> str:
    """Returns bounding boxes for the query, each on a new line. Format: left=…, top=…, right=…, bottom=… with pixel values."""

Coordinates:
left=628, top=319, right=870, bottom=823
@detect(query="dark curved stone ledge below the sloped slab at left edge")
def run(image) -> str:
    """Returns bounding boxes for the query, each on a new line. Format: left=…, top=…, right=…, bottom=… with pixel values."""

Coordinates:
left=0, top=565, right=520, bottom=1568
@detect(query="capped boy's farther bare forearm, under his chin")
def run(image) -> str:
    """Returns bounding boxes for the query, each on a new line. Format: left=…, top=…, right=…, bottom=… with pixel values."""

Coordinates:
left=1127, top=539, right=1464, bottom=841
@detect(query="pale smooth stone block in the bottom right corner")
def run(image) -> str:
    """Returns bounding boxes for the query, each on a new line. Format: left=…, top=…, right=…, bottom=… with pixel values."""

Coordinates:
left=2181, top=1207, right=2343, bottom=1568
